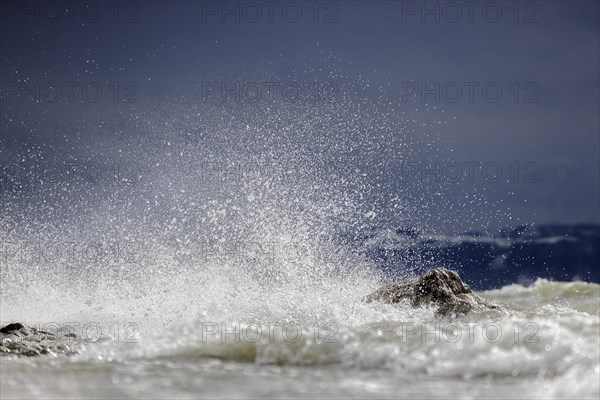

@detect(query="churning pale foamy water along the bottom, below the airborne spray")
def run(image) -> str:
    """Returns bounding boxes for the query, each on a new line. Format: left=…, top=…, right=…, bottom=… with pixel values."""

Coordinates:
left=0, top=280, right=600, bottom=399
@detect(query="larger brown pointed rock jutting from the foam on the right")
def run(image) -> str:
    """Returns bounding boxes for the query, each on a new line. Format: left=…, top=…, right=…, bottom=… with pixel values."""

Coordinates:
left=365, top=268, right=500, bottom=315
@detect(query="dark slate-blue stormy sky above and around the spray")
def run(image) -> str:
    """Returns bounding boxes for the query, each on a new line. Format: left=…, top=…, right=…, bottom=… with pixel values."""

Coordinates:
left=0, top=0, right=600, bottom=233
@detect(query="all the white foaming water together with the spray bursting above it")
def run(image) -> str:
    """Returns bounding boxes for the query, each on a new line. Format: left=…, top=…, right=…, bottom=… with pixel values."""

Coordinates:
left=0, top=80, right=600, bottom=399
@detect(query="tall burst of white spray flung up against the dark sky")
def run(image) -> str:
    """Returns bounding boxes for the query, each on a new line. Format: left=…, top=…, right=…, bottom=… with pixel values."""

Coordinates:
left=2, top=80, right=432, bottom=325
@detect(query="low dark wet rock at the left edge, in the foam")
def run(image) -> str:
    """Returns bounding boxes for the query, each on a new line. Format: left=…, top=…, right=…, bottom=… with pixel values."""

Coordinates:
left=0, top=323, right=78, bottom=357
